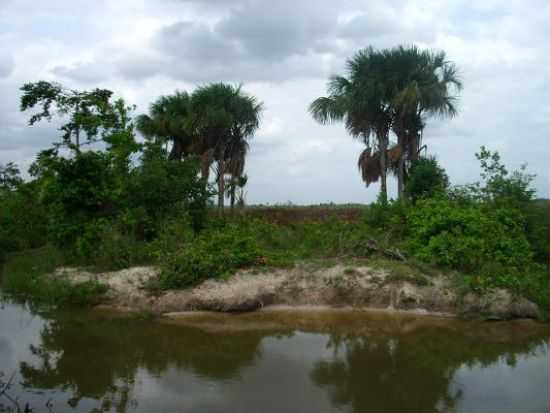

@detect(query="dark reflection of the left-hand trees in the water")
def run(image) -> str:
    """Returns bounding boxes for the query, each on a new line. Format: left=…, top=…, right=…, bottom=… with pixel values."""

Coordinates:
left=20, top=314, right=274, bottom=412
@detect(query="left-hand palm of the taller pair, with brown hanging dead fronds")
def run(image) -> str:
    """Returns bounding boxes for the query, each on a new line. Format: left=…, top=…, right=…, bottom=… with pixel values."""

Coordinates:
left=309, top=47, right=392, bottom=200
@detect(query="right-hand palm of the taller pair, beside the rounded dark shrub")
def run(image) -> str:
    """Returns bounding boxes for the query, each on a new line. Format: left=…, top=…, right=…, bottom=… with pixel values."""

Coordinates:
left=382, top=46, right=462, bottom=198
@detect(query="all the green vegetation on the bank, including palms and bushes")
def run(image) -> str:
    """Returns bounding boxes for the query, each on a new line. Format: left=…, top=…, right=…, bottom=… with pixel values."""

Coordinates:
left=0, top=48, right=550, bottom=316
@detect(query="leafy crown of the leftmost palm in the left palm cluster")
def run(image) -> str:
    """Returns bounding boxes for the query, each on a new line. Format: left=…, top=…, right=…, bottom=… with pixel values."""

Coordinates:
left=137, top=92, right=194, bottom=160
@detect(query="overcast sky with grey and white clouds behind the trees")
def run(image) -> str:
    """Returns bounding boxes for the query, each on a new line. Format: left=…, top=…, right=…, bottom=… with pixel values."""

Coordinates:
left=0, top=0, right=550, bottom=204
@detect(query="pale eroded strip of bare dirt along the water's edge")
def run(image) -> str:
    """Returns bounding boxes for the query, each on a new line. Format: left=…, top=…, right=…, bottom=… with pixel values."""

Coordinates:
left=55, top=264, right=539, bottom=319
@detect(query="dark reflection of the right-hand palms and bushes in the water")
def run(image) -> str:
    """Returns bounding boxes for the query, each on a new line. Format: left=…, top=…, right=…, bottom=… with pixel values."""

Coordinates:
left=311, top=323, right=547, bottom=413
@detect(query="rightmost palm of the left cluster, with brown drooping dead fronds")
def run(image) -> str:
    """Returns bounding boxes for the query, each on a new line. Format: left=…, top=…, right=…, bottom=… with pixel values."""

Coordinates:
left=192, top=83, right=262, bottom=208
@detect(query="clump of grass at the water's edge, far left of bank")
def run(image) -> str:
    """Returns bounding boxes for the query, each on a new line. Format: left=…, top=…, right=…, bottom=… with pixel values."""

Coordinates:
left=1, top=246, right=107, bottom=306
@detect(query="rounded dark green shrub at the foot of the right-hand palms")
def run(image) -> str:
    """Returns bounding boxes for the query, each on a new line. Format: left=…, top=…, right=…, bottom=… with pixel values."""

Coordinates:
left=405, top=157, right=449, bottom=202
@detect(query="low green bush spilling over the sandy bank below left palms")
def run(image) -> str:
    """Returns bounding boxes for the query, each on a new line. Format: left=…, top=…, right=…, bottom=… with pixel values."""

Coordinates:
left=160, top=224, right=263, bottom=289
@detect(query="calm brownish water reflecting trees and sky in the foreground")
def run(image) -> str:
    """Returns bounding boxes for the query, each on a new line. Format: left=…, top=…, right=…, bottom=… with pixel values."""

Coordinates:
left=0, top=303, right=550, bottom=413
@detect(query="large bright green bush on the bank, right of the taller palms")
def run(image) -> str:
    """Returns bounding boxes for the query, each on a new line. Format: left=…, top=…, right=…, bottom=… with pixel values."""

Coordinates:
left=408, top=198, right=532, bottom=272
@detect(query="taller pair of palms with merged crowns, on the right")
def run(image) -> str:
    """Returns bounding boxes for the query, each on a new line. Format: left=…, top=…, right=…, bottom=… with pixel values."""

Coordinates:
left=310, top=46, right=462, bottom=199
